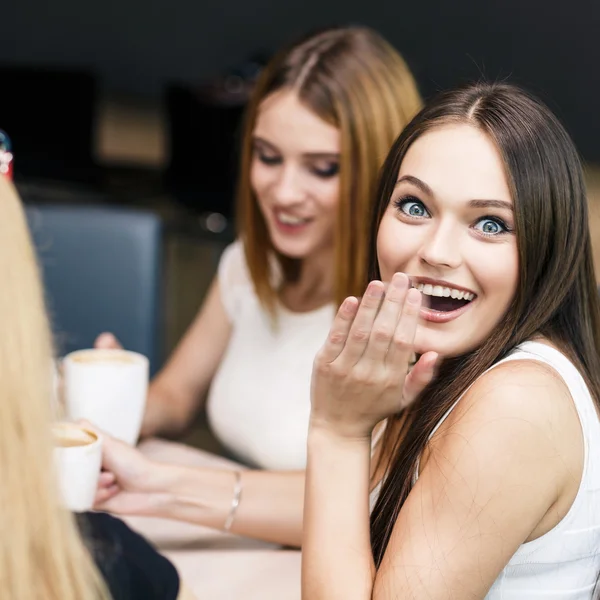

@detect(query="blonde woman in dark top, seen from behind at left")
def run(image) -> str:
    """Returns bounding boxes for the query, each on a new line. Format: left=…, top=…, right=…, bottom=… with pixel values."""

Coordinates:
left=0, top=176, right=192, bottom=600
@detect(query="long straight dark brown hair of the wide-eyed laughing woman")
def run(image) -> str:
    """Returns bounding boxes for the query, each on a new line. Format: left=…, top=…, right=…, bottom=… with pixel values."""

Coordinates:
left=371, top=83, right=600, bottom=565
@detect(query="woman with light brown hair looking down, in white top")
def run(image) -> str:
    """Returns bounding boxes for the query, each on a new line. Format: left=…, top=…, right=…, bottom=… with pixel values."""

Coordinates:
left=94, top=27, right=420, bottom=545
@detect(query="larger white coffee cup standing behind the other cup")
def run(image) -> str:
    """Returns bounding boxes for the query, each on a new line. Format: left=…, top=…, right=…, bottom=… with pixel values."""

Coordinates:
left=63, top=349, right=148, bottom=445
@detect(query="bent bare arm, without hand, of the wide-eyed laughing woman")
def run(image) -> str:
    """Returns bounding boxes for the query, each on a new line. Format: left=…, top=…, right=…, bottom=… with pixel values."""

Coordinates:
left=303, top=361, right=583, bottom=600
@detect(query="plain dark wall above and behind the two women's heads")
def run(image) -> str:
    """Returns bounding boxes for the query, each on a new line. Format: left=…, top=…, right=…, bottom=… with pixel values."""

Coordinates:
left=0, top=0, right=600, bottom=161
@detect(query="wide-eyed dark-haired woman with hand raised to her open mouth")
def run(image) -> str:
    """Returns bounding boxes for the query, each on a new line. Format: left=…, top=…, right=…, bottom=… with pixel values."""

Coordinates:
left=303, top=84, right=600, bottom=600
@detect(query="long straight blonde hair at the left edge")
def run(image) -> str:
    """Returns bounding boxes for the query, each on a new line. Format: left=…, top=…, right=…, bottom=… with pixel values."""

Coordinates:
left=0, top=177, right=109, bottom=600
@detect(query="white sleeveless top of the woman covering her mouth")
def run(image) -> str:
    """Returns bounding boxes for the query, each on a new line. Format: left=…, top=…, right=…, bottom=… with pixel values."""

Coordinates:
left=371, top=342, right=600, bottom=600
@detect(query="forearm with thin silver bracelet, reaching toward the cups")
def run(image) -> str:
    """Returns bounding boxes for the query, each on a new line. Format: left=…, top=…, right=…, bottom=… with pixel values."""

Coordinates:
left=147, top=465, right=304, bottom=546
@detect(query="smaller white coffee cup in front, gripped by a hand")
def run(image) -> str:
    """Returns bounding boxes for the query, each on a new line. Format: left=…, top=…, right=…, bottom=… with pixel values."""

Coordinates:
left=52, top=423, right=102, bottom=512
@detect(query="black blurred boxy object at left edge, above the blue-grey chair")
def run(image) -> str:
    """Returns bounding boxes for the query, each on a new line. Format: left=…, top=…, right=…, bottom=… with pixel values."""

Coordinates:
left=0, top=66, right=98, bottom=185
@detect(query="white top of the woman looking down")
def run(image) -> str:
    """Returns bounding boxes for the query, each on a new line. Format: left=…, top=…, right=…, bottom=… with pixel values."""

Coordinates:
left=207, top=242, right=335, bottom=470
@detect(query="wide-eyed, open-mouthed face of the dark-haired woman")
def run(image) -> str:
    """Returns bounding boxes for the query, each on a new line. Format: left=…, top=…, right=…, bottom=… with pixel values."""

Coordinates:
left=377, top=124, right=518, bottom=356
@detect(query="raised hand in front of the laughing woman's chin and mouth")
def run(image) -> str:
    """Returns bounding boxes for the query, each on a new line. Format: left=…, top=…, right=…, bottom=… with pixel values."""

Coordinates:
left=311, top=273, right=437, bottom=438
